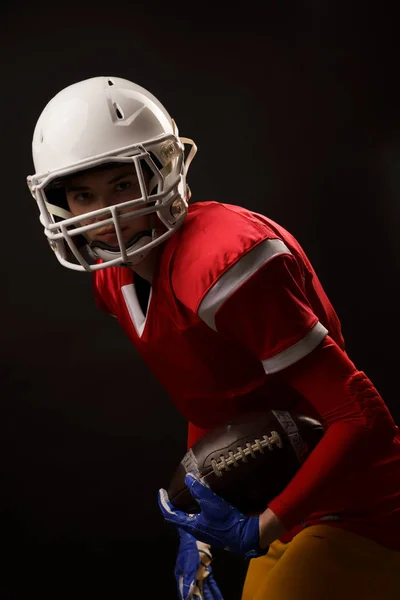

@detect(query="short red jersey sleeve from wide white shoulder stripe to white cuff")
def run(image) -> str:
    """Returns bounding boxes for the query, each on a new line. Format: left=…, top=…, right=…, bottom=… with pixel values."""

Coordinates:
left=202, top=239, right=328, bottom=374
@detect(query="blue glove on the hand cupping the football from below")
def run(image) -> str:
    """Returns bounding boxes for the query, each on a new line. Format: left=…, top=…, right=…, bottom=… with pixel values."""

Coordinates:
left=158, top=473, right=268, bottom=558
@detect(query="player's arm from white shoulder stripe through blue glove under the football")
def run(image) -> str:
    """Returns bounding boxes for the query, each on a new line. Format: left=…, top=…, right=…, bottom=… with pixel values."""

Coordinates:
left=167, top=239, right=397, bottom=556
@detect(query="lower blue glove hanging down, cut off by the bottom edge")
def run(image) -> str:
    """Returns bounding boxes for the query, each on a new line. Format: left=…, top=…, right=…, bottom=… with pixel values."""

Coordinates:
left=175, top=527, right=223, bottom=600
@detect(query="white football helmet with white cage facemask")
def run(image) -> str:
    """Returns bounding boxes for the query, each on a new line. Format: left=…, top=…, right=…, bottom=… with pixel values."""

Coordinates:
left=27, top=77, right=197, bottom=271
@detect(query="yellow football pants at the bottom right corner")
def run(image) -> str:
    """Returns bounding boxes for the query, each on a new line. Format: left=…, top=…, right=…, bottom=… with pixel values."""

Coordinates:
left=242, top=525, right=400, bottom=600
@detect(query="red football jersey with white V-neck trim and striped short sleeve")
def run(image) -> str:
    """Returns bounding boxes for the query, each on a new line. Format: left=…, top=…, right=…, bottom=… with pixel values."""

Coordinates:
left=94, top=202, right=343, bottom=429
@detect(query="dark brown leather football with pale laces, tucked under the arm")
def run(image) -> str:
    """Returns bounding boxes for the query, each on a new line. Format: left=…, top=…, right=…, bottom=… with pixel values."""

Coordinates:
left=167, top=410, right=324, bottom=515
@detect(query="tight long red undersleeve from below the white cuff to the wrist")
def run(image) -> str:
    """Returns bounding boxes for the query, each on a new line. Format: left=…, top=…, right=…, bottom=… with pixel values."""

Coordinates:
left=269, top=336, right=398, bottom=531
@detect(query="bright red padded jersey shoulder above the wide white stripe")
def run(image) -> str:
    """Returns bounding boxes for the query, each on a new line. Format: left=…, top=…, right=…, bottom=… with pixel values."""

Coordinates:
left=171, top=202, right=290, bottom=312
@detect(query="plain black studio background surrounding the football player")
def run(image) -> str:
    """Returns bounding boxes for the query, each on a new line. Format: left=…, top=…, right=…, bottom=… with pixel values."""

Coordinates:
left=0, top=0, right=400, bottom=600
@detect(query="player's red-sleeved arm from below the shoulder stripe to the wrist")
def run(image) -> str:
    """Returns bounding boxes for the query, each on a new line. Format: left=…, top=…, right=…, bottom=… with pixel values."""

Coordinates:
left=211, top=250, right=397, bottom=543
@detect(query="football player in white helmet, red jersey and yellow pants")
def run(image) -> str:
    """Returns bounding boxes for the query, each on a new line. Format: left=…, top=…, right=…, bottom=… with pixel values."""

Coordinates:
left=28, top=77, right=400, bottom=600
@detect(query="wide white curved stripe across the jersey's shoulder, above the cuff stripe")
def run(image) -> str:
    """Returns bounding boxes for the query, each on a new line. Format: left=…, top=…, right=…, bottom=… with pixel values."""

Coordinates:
left=198, top=239, right=291, bottom=331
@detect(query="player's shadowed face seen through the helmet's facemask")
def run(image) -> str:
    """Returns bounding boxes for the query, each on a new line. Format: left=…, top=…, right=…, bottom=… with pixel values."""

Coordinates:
left=65, top=164, right=150, bottom=246
